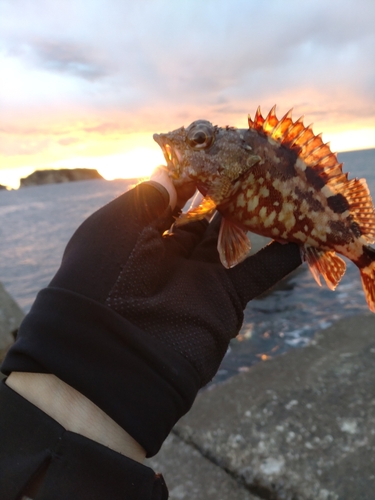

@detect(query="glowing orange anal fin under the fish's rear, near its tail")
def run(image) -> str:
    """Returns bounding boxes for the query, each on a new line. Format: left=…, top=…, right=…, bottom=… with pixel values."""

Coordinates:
left=302, top=247, right=346, bottom=290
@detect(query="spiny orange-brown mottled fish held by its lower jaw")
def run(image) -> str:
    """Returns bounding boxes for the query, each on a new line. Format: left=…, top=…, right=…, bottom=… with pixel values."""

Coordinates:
left=153, top=106, right=375, bottom=312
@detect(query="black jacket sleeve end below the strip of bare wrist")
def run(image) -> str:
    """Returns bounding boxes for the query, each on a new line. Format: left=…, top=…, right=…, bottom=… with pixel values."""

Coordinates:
left=0, top=382, right=168, bottom=500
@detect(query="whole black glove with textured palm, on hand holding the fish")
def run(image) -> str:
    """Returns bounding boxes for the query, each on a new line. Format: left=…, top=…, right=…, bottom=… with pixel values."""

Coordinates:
left=2, top=183, right=301, bottom=456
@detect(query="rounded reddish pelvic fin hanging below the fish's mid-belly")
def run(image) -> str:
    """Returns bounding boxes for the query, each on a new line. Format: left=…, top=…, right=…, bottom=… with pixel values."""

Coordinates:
left=217, top=218, right=251, bottom=269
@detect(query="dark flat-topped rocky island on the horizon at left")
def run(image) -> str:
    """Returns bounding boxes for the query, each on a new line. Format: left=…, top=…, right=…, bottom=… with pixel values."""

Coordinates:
left=20, top=168, right=103, bottom=187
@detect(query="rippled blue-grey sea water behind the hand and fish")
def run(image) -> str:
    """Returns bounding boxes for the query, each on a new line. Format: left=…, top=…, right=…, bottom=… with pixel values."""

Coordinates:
left=0, top=149, right=375, bottom=384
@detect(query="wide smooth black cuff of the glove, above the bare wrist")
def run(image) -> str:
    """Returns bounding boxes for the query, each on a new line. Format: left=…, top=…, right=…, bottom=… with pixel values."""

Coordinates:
left=2, top=287, right=200, bottom=456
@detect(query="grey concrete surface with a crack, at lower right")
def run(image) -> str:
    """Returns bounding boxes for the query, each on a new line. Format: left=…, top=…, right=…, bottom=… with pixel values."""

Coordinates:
left=149, top=314, right=375, bottom=500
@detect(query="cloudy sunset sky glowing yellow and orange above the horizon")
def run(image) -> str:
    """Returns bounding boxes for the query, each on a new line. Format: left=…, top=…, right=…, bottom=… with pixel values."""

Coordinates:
left=0, top=0, right=375, bottom=187
